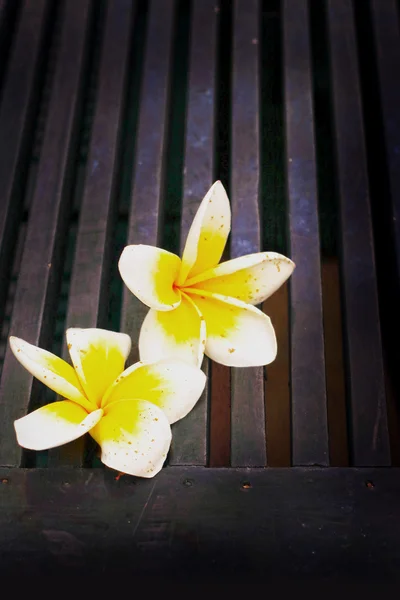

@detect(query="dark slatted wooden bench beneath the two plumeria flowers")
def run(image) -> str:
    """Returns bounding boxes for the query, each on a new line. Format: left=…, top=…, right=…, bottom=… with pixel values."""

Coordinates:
left=0, top=0, right=400, bottom=582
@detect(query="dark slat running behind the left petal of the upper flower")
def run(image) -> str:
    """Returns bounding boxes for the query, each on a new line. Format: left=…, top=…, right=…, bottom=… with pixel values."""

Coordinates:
left=121, top=0, right=175, bottom=362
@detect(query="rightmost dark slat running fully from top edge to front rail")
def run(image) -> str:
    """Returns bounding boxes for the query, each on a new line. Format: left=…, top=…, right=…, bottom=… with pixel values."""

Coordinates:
left=328, top=0, right=390, bottom=466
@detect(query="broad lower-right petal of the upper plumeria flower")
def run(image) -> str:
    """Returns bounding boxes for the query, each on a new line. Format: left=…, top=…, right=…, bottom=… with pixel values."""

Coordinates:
left=186, top=290, right=277, bottom=367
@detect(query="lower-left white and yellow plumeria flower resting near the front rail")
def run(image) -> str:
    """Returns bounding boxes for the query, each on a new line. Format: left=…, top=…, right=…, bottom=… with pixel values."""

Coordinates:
left=10, top=328, right=206, bottom=477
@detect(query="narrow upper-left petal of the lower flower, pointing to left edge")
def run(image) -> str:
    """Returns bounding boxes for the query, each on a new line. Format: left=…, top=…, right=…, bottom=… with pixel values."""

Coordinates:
left=10, top=336, right=93, bottom=411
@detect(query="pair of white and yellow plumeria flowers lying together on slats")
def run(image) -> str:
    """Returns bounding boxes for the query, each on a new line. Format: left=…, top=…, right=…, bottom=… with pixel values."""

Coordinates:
left=10, top=182, right=294, bottom=477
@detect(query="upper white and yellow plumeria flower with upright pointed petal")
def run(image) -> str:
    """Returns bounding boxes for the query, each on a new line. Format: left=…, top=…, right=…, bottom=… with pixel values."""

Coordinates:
left=119, top=181, right=295, bottom=367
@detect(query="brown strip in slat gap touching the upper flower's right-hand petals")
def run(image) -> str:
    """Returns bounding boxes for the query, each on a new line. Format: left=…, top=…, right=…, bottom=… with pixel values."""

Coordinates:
left=263, top=283, right=291, bottom=467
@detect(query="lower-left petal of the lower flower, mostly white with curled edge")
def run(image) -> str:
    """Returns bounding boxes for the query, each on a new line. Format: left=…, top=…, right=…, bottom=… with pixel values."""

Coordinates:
left=14, top=400, right=103, bottom=450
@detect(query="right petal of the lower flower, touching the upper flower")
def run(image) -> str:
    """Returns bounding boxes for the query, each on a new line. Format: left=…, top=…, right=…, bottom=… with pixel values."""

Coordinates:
left=102, top=360, right=206, bottom=423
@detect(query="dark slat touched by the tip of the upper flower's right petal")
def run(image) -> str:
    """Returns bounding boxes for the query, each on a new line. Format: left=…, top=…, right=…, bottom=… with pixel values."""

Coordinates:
left=283, top=0, right=329, bottom=465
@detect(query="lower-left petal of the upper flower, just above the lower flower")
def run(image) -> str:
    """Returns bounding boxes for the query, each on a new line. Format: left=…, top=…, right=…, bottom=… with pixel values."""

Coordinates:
left=139, top=294, right=206, bottom=367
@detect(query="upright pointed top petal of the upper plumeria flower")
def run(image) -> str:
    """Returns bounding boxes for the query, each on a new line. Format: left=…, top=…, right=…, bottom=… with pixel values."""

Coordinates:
left=178, top=181, right=231, bottom=285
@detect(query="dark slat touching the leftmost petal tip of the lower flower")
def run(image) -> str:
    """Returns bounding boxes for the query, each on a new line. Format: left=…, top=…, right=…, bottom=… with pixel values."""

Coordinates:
left=0, top=0, right=90, bottom=466
